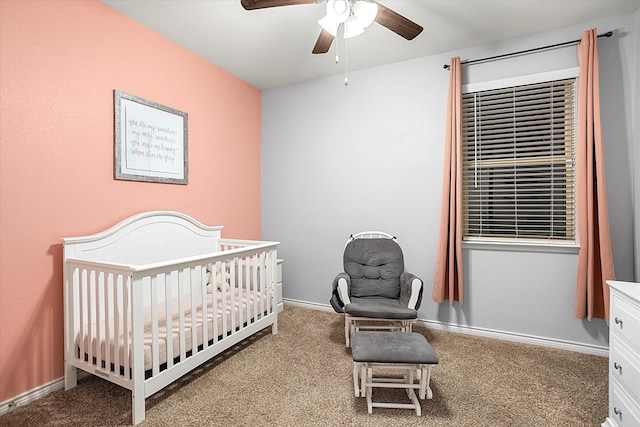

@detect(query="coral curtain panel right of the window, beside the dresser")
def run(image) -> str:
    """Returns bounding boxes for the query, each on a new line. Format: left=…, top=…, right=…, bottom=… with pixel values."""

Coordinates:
left=575, top=28, right=615, bottom=322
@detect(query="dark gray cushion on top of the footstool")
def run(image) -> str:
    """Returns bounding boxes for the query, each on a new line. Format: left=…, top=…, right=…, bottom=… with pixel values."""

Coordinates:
left=351, top=332, right=438, bottom=364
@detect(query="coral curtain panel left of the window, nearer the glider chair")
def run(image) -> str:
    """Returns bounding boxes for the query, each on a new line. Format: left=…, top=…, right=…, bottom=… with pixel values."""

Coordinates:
left=431, top=57, right=463, bottom=303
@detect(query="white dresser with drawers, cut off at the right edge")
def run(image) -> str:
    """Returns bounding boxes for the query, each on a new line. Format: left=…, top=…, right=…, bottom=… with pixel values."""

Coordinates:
left=602, top=280, right=640, bottom=427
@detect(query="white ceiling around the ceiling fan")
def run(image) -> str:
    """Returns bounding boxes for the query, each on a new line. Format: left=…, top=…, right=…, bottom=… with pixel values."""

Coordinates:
left=102, top=0, right=640, bottom=89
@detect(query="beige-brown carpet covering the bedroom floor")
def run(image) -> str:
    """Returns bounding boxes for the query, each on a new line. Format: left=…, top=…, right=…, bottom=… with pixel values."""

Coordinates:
left=0, top=306, right=608, bottom=427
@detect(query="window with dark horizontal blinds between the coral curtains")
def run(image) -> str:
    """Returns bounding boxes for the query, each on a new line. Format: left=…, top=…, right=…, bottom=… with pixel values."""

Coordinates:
left=462, top=78, right=577, bottom=243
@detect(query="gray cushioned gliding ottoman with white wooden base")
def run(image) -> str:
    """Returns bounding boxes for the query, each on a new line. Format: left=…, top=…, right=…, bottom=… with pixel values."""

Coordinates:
left=351, top=332, right=438, bottom=416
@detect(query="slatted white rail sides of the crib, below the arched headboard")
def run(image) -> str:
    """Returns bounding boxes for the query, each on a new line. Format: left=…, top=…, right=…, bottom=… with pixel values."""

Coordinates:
left=65, top=239, right=277, bottom=396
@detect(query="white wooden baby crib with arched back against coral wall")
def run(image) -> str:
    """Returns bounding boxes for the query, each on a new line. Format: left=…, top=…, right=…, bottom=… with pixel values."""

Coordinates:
left=62, top=211, right=278, bottom=424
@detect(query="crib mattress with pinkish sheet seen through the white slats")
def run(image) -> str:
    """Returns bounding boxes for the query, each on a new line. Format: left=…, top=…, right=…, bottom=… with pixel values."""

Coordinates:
left=76, top=289, right=268, bottom=371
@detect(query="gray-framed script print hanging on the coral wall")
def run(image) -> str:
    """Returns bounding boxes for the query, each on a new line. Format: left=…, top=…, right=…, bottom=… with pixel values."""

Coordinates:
left=113, top=90, right=189, bottom=185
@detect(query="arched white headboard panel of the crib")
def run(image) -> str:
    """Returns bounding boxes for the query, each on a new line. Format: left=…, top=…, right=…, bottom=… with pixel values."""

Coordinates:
left=62, top=211, right=223, bottom=265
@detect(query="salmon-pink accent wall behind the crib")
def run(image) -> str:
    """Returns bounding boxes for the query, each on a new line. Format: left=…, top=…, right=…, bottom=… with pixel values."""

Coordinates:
left=0, top=0, right=261, bottom=402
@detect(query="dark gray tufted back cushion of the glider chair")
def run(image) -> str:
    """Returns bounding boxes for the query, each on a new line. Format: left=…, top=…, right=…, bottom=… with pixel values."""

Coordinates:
left=343, top=239, right=404, bottom=299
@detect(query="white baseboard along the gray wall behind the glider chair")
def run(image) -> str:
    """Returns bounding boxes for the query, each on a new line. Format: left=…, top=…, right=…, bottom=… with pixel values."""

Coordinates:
left=283, top=298, right=609, bottom=357
